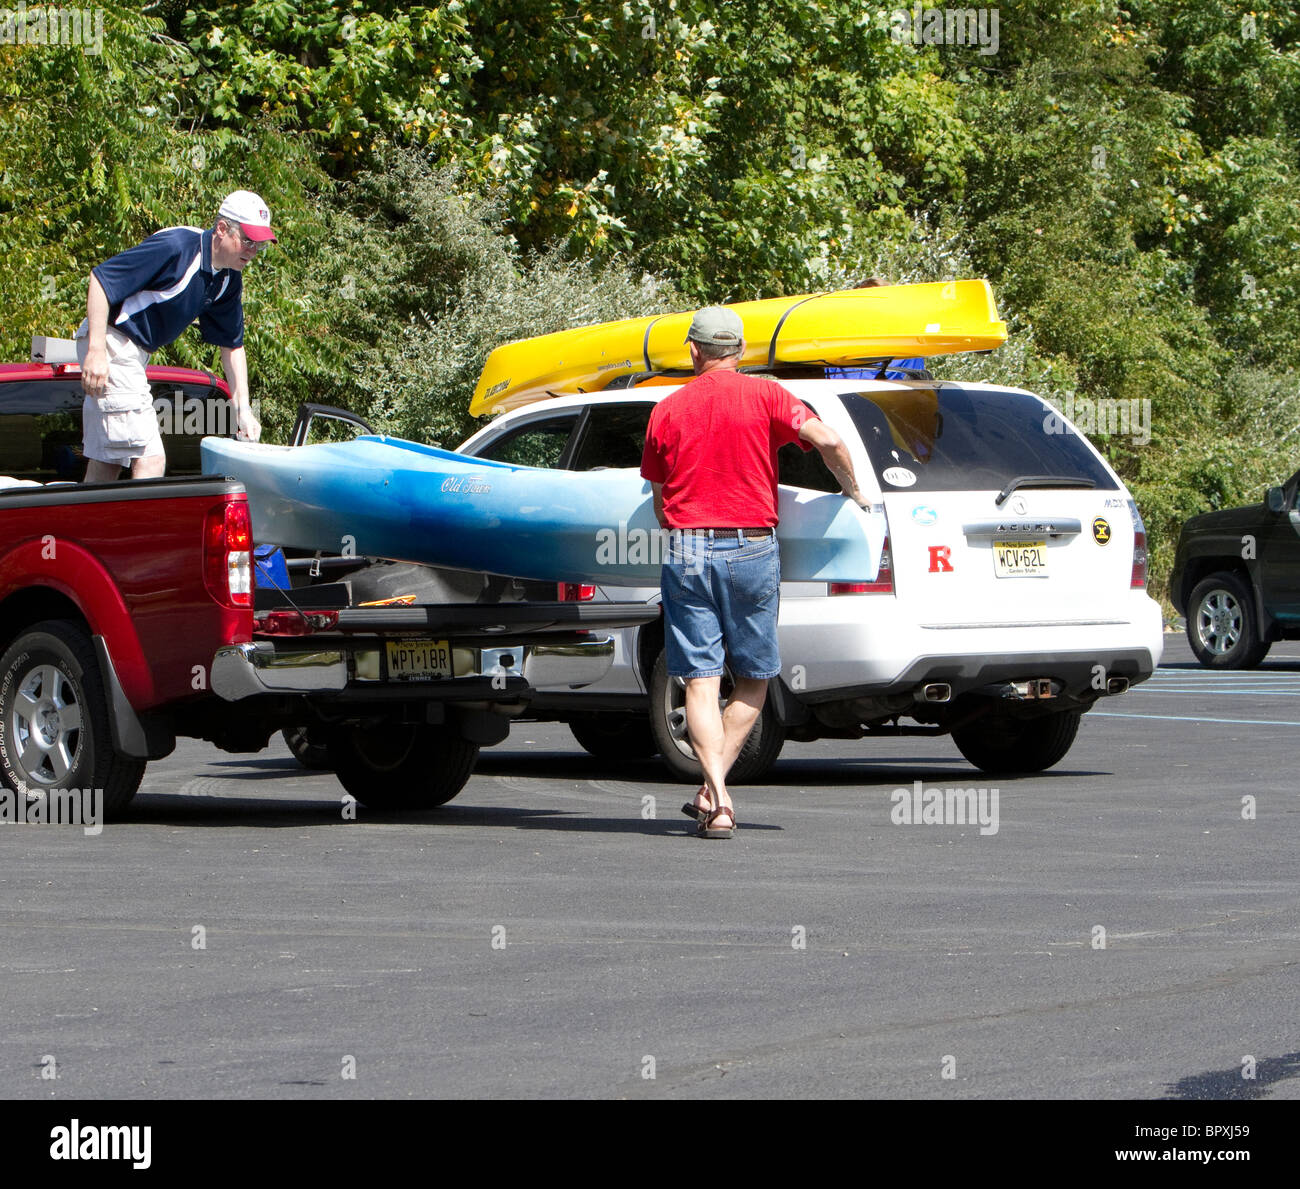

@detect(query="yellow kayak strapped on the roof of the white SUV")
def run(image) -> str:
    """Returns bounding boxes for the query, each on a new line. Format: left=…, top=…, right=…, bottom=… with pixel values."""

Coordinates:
left=469, top=281, right=1006, bottom=417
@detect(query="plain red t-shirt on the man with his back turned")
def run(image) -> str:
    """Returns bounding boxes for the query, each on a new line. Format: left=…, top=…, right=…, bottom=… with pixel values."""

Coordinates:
left=641, top=369, right=816, bottom=529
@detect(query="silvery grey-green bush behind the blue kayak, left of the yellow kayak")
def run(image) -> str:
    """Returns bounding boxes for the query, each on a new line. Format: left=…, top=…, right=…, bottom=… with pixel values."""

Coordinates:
left=327, top=152, right=675, bottom=446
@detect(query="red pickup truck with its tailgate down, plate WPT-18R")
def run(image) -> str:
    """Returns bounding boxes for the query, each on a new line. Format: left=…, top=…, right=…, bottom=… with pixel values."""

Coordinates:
left=0, top=353, right=645, bottom=815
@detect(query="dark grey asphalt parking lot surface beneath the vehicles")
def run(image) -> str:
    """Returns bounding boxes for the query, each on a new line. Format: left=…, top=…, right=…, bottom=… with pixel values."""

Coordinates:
left=0, top=635, right=1300, bottom=1101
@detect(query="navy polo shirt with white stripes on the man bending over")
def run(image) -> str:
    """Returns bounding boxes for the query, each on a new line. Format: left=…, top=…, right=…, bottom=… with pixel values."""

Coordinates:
left=94, top=227, right=243, bottom=355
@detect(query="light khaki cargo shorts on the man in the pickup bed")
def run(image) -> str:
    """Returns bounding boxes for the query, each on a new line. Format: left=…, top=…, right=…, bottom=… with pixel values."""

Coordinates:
left=77, top=321, right=164, bottom=467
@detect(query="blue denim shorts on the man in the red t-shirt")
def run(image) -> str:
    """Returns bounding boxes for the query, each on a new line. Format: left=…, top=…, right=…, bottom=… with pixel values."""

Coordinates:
left=659, top=531, right=781, bottom=678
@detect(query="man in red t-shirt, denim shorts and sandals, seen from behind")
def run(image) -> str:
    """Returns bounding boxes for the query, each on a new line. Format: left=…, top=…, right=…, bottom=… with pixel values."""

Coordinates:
left=641, top=305, right=862, bottom=838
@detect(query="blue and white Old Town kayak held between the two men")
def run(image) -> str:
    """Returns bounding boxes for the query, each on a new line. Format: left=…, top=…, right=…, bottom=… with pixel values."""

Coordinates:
left=202, top=435, right=884, bottom=586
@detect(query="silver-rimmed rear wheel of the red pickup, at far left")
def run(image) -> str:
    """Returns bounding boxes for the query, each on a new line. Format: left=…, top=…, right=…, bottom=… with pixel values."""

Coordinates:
left=0, top=620, right=144, bottom=816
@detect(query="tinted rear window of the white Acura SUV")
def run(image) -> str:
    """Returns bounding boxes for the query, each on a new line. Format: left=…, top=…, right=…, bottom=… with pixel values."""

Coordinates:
left=840, top=385, right=1118, bottom=491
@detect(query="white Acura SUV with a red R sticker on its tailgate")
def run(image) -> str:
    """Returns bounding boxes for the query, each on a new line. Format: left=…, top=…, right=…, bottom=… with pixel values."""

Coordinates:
left=459, top=379, right=1164, bottom=782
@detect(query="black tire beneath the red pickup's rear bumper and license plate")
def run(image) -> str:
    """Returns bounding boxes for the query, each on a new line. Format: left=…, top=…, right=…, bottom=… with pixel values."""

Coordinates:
left=329, top=722, right=478, bottom=810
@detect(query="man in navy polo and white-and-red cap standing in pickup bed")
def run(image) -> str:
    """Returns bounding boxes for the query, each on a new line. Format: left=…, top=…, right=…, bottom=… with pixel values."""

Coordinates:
left=77, top=190, right=276, bottom=483
